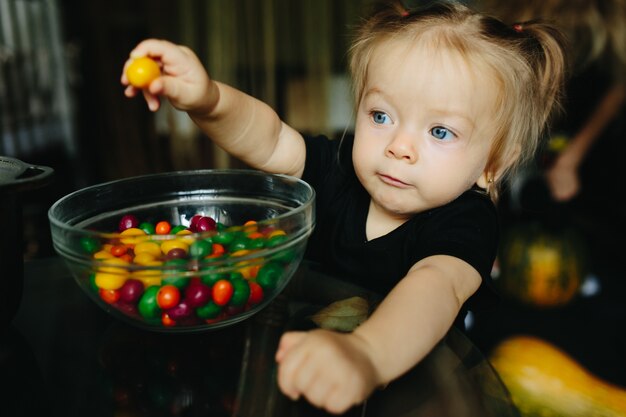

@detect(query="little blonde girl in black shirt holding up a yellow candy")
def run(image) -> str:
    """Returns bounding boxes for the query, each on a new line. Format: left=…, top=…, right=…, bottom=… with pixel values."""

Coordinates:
left=122, top=2, right=564, bottom=413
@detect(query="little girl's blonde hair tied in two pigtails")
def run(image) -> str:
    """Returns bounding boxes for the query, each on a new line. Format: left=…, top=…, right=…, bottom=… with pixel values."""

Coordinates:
left=349, top=1, right=565, bottom=199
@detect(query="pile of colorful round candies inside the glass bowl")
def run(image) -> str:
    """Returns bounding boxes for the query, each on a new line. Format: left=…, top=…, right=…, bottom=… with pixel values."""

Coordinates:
left=81, top=214, right=293, bottom=327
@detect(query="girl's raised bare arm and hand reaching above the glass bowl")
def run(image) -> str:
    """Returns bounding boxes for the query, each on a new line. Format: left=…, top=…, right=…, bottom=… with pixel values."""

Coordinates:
left=121, top=39, right=305, bottom=177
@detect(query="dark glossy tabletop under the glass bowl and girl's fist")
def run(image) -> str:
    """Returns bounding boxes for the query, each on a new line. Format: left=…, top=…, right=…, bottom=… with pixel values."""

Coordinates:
left=0, top=258, right=518, bottom=417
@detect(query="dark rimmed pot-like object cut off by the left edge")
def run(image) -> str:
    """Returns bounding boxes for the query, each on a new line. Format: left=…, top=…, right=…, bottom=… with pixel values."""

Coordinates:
left=0, top=156, right=54, bottom=330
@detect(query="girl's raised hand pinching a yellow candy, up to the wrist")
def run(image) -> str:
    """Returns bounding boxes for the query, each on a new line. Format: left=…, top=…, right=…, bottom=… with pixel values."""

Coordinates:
left=121, top=39, right=219, bottom=115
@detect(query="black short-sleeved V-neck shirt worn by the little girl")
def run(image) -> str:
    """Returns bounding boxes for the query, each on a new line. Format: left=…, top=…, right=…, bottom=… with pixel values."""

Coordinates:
left=302, top=136, right=498, bottom=318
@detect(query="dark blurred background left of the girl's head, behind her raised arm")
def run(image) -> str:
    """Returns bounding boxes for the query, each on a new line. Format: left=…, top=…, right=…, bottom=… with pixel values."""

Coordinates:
left=0, top=0, right=366, bottom=259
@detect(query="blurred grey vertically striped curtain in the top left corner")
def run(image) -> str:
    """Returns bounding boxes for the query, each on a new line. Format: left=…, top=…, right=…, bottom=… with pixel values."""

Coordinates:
left=0, top=0, right=76, bottom=159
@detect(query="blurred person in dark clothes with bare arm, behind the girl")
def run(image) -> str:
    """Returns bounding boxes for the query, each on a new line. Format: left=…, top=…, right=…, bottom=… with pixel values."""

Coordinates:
left=475, top=0, right=626, bottom=284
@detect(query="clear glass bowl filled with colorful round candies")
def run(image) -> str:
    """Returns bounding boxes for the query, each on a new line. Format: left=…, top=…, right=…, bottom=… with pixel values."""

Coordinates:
left=48, top=170, right=315, bottom=332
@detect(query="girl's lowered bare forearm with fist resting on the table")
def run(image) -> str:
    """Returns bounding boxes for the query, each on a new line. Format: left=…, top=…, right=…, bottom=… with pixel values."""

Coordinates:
left=276, top=255, right=480, bottom=413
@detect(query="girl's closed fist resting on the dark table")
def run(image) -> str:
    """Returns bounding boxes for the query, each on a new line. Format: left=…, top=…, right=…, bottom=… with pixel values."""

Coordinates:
left=276, top=330, right=382, bottom=414
